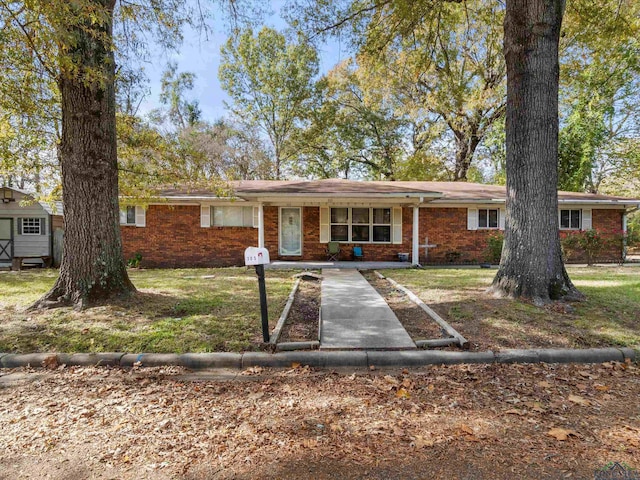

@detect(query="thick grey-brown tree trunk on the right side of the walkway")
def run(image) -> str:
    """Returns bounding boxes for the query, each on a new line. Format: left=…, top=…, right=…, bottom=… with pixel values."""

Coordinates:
left=492, top=0, right=581, bottom=304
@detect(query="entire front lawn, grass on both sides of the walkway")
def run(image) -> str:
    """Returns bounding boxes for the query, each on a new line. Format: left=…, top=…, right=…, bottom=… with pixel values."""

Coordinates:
left=0, top=267, right=640, bottom=353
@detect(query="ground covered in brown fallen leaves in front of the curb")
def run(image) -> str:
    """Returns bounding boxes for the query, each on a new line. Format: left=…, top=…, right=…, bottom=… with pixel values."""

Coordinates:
left=0, top=363, right=640, bottom=480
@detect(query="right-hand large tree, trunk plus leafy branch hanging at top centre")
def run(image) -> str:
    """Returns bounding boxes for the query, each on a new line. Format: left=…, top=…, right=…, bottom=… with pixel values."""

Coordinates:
left=294, top=0, right=581, bottom=303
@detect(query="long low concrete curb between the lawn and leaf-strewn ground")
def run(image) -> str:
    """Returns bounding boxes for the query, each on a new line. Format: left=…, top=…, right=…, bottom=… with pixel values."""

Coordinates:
left=0, top=348, right=636, bottom=370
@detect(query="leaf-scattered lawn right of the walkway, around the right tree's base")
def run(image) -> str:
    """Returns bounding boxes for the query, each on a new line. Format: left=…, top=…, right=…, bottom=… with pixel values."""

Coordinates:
left=385, top=266, right=640, bottom=350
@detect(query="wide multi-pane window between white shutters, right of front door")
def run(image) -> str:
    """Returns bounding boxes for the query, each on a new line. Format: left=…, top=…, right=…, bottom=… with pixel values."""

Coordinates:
left=330, top=207, right=391, bottom=243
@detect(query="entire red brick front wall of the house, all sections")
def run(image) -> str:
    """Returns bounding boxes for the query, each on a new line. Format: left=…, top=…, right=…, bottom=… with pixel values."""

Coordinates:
left=121, top=205, right=622, bottom=267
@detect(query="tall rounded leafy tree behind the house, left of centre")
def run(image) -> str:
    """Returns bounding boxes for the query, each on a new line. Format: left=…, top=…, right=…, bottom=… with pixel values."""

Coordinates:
left=219, top=27, right=318, bottom=179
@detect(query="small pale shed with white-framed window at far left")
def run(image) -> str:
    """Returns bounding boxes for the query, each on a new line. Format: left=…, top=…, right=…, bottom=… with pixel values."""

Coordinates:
left=0, top=187, right=63, bottom=270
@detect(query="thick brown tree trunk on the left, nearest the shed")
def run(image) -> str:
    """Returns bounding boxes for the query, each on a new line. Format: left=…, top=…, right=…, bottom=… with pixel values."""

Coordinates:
left=32, top=0, right=135, bottom=308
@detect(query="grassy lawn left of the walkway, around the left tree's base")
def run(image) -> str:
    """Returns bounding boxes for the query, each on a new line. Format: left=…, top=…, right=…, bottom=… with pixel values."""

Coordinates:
left=0, top=268, right=294, bottom=353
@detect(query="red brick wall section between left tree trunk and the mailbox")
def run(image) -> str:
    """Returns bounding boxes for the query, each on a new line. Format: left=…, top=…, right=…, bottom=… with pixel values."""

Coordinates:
left=120, top=205, right=258, bottom=267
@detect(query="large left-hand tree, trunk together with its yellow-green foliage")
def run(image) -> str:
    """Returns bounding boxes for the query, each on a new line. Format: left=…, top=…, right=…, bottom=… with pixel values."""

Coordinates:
left=0, top=0, right=238, bottom=308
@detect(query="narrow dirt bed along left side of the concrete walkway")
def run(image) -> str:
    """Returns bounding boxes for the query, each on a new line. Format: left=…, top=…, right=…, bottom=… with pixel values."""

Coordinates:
left=279, top=280, right=321, bottom=342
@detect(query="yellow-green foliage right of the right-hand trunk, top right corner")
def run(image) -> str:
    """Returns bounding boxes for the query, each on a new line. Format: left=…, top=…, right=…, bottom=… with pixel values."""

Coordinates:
left=559, top=0, right=640, bottom=193
